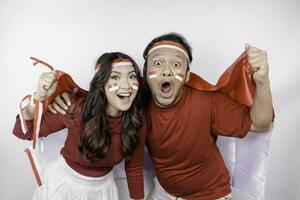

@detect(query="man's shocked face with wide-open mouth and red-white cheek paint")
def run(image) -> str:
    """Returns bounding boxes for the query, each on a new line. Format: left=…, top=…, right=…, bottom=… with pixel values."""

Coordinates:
left=147, top=48, right=189, bottom=107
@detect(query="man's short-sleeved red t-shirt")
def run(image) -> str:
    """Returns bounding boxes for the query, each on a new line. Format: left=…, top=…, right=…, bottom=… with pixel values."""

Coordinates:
left=147, top=86, right=251, bottom=200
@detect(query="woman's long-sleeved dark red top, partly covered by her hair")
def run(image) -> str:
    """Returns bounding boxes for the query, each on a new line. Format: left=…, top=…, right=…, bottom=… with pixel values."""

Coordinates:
left=13, top=98, right=147, bottom=199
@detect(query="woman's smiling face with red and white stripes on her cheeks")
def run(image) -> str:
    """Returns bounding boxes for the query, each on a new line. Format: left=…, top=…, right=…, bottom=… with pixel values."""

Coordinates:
left=104, top=65, right=139, bottom=117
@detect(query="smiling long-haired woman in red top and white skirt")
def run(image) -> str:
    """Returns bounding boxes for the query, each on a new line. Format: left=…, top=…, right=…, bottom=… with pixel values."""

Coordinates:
left=13, top=52, right=146, bottom=200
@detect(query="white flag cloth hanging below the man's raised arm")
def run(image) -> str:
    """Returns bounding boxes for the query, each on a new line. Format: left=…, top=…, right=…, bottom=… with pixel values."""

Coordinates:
left=218, top=124, right=272, bottom=200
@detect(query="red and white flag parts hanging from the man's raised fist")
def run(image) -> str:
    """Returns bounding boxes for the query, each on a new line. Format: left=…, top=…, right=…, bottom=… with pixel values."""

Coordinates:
left=186, top=52, right=272, bottom=200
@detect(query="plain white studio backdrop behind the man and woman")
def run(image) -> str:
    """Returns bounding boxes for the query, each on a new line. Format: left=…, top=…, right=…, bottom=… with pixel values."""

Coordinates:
left=0, top=0, right=300, bottom=200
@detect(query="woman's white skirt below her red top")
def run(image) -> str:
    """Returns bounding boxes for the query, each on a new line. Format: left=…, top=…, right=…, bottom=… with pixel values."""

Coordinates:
left=33, top=155, right=119, bottom=200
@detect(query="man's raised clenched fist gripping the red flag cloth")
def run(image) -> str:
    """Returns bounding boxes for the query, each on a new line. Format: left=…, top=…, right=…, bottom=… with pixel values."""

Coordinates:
left=245, top=44, right=269, bottom=84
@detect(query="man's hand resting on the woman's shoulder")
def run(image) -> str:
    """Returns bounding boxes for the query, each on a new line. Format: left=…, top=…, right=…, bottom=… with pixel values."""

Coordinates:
left=48, top=92, right=71, bottom=115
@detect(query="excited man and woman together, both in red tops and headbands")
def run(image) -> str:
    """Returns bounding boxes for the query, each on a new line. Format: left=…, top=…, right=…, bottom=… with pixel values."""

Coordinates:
left=14, top=33, right=273, bottom=200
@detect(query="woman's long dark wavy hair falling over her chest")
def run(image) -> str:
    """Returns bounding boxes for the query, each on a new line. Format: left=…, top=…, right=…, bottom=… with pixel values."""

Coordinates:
left=78, top=52, right=142, bottom=161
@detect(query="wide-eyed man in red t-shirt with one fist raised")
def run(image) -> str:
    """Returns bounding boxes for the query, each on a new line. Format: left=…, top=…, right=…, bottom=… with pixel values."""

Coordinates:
left=49, top=33, right=273, bottom=200
